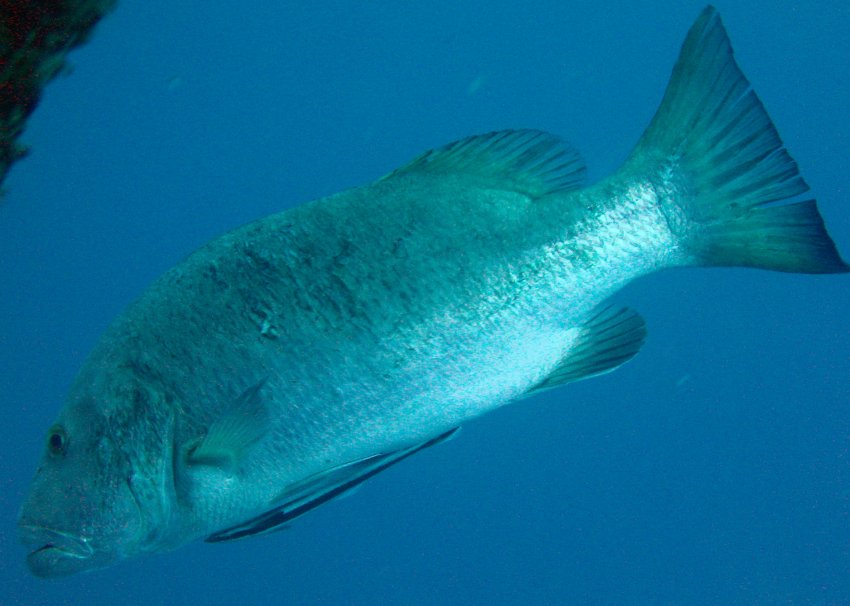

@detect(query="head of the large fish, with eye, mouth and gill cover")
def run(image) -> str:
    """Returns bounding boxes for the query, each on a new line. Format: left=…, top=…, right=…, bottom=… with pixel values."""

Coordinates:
left=18, top=376, right=170, bottom=577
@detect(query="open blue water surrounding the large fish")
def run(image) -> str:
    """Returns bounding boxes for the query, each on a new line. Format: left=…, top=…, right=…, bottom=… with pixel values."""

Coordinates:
left=0, top=0, right=850, bottom=606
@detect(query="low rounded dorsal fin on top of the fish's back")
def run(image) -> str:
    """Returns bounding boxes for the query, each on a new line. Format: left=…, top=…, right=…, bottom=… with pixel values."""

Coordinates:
left=382, top=130, right=586, bottom=198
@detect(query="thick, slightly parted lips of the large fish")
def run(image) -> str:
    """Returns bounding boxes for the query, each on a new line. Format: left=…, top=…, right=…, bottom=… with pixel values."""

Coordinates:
left=21, top=526, right=95, bottom=578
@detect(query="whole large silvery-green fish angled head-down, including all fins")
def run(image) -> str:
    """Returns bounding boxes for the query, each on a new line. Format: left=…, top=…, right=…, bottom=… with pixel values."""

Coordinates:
left=19, top=7, right=850, bottom=577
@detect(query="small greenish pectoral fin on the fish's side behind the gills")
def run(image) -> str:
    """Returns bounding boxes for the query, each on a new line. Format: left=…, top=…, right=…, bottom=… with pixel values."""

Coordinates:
left=185, top=379, right=269, bottom=472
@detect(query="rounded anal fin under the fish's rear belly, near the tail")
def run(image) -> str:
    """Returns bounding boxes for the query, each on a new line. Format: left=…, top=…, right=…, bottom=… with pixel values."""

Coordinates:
left=525, top=307, right=646, bottom=396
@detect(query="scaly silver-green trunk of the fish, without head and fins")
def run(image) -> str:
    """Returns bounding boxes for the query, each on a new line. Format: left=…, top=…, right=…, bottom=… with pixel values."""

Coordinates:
left=74, top=167, right=665, bottom=536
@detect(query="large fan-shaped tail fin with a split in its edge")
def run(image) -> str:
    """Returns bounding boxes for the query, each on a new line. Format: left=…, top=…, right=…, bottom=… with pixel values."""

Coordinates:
left=628, top=6, right=850, bottom=273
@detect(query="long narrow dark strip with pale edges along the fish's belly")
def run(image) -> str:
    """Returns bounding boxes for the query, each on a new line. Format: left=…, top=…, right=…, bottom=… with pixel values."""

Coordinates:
left=206, top=427, right=459, bottom=543
